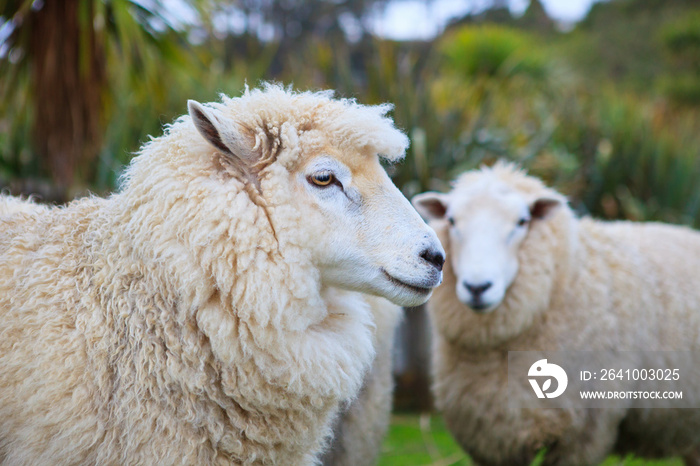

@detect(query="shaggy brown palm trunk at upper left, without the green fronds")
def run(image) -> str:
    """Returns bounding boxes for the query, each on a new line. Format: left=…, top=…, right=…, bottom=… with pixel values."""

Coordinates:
left=29, top=0, right=106, bottom=192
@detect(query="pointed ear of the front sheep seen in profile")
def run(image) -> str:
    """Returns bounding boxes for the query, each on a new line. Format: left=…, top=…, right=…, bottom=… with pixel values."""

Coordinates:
left=187, top=100, right=256, bottom=171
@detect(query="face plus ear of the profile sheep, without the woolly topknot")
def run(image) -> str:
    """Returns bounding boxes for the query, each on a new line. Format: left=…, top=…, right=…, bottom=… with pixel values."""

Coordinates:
left=189, top=97, right=445, bottom=306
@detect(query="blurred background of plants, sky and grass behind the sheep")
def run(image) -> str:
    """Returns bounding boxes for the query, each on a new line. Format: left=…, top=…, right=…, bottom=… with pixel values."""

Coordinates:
left=0, top=0, right=700, bottom=465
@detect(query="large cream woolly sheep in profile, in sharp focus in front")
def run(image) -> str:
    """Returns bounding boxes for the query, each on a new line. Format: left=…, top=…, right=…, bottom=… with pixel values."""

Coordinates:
left=0, top=84, right=444, bottom=465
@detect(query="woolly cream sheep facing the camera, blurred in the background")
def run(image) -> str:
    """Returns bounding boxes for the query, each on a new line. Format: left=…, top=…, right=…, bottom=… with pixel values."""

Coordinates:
left=413, top=163, right=700, bottom=465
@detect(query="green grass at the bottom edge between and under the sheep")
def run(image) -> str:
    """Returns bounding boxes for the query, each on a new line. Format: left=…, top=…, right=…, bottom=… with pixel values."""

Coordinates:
left=378, top=413, right=683, bottom=466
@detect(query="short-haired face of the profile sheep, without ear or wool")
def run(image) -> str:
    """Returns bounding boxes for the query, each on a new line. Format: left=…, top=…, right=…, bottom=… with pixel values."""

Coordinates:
left=295, top=151, right=445, bottom=306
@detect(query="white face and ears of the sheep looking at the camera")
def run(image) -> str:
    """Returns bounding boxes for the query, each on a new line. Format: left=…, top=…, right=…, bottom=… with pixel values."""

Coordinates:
left=413, top=183, right=560, bottom=313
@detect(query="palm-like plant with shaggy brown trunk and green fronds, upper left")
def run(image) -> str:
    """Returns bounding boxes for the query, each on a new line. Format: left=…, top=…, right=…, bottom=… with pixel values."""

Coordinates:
left=0, top=0, right=204, bottom=198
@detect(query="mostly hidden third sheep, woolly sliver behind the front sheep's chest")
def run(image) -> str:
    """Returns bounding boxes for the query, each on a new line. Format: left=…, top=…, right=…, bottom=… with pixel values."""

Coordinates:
left=321, top=297, right=402, bottom=466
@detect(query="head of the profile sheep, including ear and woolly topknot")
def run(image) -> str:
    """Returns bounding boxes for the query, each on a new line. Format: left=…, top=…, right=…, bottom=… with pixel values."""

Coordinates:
left=183, top=87, right=444, bottom=306
